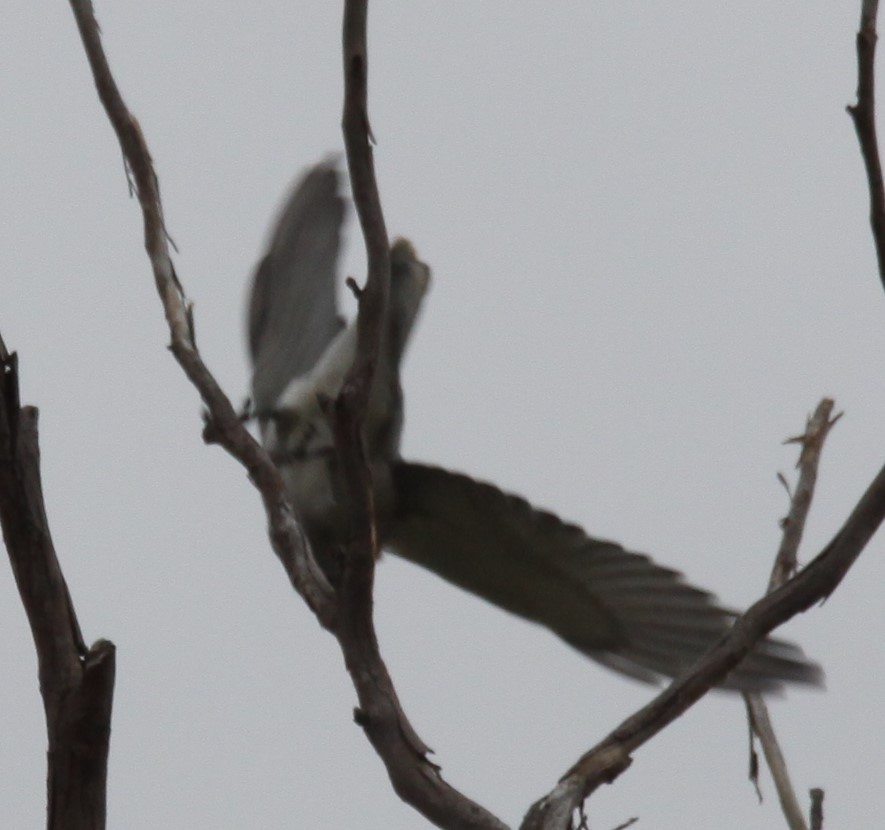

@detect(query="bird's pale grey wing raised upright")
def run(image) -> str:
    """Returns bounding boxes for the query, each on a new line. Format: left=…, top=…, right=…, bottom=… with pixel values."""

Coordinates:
left=249, top=163, right=344, bottom=414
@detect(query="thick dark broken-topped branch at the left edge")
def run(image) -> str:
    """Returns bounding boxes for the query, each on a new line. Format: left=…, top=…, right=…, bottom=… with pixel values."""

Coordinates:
left=0, top=339, right=115, bottom=830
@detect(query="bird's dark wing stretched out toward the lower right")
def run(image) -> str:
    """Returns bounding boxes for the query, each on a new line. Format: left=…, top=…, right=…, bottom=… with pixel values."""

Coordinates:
left=385, top=462, right=822, bottom=691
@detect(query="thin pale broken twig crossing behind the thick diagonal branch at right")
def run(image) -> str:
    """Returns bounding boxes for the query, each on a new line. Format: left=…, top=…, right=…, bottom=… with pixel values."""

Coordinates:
left=744, top=398, right=841, bottom=830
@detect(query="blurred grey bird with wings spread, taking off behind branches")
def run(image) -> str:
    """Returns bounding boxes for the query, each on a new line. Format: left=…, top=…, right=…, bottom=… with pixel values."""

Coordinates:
left=247, top=160, right=823, bottom=693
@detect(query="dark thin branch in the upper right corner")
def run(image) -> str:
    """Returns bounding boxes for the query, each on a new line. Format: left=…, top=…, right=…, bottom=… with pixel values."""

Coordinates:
left=848, top=0, right=885, bottom=296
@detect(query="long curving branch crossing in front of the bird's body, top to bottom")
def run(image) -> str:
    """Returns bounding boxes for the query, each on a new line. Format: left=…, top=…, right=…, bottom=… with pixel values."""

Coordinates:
left=333, top=0, right=504, bottom=828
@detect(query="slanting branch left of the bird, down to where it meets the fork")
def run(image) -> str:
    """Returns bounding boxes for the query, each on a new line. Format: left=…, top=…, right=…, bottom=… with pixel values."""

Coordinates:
left=64, top=0, right=336, bottom=628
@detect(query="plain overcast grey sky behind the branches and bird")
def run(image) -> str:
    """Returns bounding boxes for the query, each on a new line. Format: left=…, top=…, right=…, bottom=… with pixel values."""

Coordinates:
left=0, top=0, right=885, bottom=830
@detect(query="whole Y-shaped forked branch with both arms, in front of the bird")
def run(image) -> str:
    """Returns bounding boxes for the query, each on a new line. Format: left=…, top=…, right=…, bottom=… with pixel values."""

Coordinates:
left=70, top=0, right=504, bottom=829
